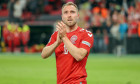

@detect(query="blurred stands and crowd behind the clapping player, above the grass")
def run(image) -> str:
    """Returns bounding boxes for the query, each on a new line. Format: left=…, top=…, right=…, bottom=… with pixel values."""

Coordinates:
left=0, top=0, right=140, bottom=56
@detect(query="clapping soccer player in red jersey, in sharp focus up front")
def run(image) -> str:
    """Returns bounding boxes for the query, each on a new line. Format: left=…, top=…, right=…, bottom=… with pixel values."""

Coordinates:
left=41, top=2, right=93, bottom=84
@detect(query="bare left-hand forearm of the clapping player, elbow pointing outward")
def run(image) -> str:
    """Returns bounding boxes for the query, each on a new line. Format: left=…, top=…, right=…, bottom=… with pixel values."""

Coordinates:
left=41, top=42, right=58, bottom=59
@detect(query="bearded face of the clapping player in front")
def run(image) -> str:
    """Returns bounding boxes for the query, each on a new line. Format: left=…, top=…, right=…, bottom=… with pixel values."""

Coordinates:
left=62, top=5, right=79, bottom=27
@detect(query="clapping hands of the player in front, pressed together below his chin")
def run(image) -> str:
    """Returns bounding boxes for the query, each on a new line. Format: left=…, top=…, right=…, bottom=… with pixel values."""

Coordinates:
left=56, top=21, right=66, bottom=39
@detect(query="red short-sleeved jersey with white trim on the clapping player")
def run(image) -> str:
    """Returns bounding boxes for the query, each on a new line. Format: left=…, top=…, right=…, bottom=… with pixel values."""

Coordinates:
left=46, top=27, right=93, bottom=84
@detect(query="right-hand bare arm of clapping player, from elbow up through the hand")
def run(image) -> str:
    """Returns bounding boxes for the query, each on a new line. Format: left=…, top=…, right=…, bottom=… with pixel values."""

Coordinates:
left=57, top=22, right=87, bottom=61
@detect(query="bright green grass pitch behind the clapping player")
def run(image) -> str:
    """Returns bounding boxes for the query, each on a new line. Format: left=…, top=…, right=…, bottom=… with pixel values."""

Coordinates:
left=0, top=53, right=140, bottom=84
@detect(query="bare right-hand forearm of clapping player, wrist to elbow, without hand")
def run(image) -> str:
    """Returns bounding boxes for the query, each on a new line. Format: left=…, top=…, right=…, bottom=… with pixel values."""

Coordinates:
left=62, top=36, right=88, bottom=61
